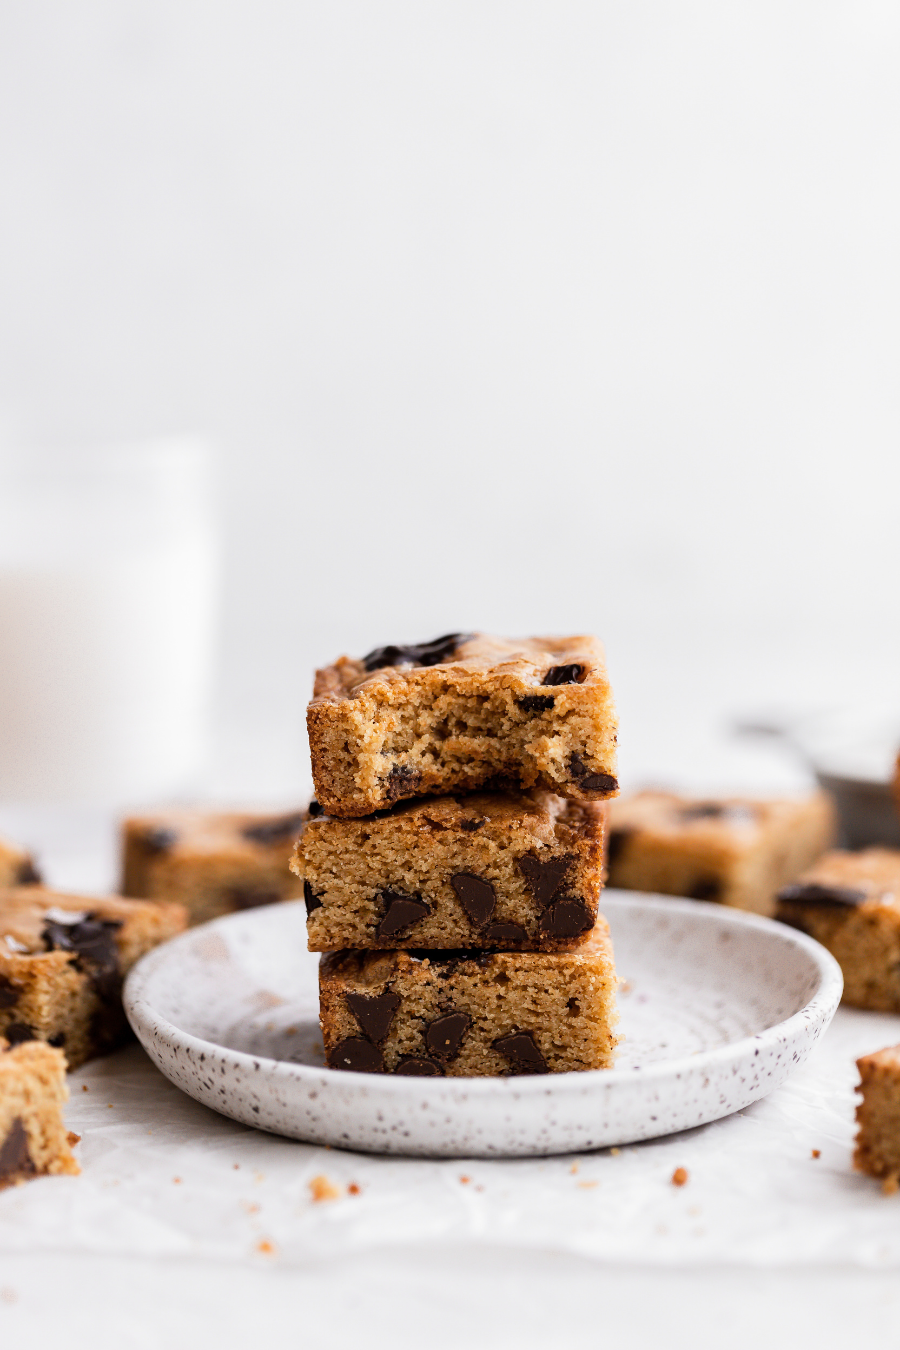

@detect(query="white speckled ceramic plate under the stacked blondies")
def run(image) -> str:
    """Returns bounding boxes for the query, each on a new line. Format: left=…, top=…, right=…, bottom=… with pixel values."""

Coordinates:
left=124, top=891, right=842, bottom=1157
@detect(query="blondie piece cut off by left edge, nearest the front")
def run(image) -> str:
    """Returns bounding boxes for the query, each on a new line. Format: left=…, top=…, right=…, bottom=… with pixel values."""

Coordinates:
left=0, top=1040, right=81, bottom=1191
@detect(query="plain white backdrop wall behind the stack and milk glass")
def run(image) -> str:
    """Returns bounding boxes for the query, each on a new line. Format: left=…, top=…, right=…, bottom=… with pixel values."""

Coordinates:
left=0, top=0, right=900, bottom=795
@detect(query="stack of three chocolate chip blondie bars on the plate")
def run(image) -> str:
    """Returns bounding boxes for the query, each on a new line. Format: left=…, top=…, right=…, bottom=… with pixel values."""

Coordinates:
left=291, top=633, right=618, bottom=1076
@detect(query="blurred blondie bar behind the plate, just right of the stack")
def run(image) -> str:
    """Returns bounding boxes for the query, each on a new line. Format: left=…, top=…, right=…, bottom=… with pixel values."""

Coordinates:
left=609, top=792, right=834, bottom=914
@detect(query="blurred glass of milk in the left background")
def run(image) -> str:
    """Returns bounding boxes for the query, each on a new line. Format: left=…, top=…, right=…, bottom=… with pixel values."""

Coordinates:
left=0, top=439, right=217, bottom=805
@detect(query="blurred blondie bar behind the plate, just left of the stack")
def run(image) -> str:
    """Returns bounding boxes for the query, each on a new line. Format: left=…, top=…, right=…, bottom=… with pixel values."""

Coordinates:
left=121, top=810, right=304, bottom=923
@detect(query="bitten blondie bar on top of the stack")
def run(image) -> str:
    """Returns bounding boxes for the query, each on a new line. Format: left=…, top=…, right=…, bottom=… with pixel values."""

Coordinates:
left=306, top=633, right=618, bottom=817
